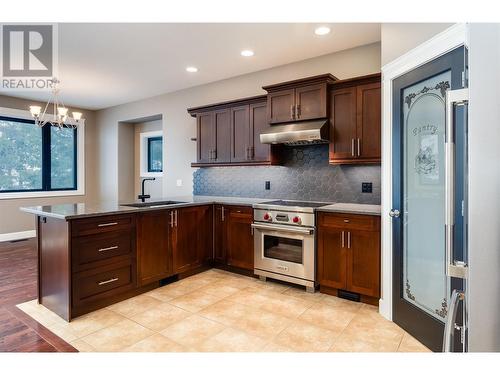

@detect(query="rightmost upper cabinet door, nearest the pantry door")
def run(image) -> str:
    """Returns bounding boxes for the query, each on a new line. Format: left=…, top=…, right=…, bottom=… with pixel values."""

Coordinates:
left=356, top=83, right=381, bottom=162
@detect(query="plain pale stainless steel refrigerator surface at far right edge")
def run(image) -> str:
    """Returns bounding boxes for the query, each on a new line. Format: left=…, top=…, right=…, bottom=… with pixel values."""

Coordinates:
left=466, top=24, right=500, bottom=352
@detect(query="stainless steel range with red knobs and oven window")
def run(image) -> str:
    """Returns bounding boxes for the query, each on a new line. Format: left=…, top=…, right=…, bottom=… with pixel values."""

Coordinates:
left=252, top=200, right=330, bottom=292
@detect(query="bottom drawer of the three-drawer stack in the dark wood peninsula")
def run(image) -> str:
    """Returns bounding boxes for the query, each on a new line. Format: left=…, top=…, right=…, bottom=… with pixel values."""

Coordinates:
left=73, top=262, right=134, bottom=306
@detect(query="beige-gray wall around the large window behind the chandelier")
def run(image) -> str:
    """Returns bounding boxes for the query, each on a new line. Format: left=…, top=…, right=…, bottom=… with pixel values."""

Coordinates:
left=0, top=95, right=98, bottom=234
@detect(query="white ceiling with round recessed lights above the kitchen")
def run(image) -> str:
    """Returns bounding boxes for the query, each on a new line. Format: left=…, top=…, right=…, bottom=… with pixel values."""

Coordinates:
left=1, top=23, right=380, bottom=109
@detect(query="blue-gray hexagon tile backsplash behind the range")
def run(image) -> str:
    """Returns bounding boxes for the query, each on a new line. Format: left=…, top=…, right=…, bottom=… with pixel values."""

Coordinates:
left=193, top=145, right=380, bottom=204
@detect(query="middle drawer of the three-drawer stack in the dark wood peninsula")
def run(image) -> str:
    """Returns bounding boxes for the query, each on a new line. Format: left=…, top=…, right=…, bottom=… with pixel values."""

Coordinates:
left=72, top=231, right=133, bottom=271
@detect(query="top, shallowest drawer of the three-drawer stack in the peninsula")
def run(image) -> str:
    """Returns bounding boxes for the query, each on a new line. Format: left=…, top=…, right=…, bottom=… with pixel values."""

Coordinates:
left=71, top=215, right=134, bottom=236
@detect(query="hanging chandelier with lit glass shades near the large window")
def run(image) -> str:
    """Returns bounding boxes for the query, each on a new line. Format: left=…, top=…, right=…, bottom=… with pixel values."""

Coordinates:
left=30, top=77, right=85, bottom=129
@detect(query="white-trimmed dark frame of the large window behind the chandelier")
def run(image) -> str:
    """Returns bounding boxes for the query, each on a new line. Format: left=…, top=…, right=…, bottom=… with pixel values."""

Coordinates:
left=0, top=107, right=85, bottom=201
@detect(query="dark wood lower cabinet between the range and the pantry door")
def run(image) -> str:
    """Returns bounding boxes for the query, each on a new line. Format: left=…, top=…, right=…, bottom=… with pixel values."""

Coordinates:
left=317, top=212, right=380, bottom=304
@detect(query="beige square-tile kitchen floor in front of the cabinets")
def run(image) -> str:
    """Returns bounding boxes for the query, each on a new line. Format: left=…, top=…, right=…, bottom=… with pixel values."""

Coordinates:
left=18, top=269, right=429, bottom=352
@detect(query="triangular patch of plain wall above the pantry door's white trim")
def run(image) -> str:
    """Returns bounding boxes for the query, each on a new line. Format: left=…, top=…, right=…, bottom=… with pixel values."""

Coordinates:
left=381, top=23, right=453, bottom=66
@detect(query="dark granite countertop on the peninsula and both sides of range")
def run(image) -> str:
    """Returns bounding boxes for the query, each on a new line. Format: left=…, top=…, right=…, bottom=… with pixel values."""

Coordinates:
left=21, top=195, right=380, bottom=220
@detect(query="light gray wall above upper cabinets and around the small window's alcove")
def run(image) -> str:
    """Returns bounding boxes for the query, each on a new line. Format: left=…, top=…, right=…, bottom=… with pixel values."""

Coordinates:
left=97, top=43, right=380, bottom=200
